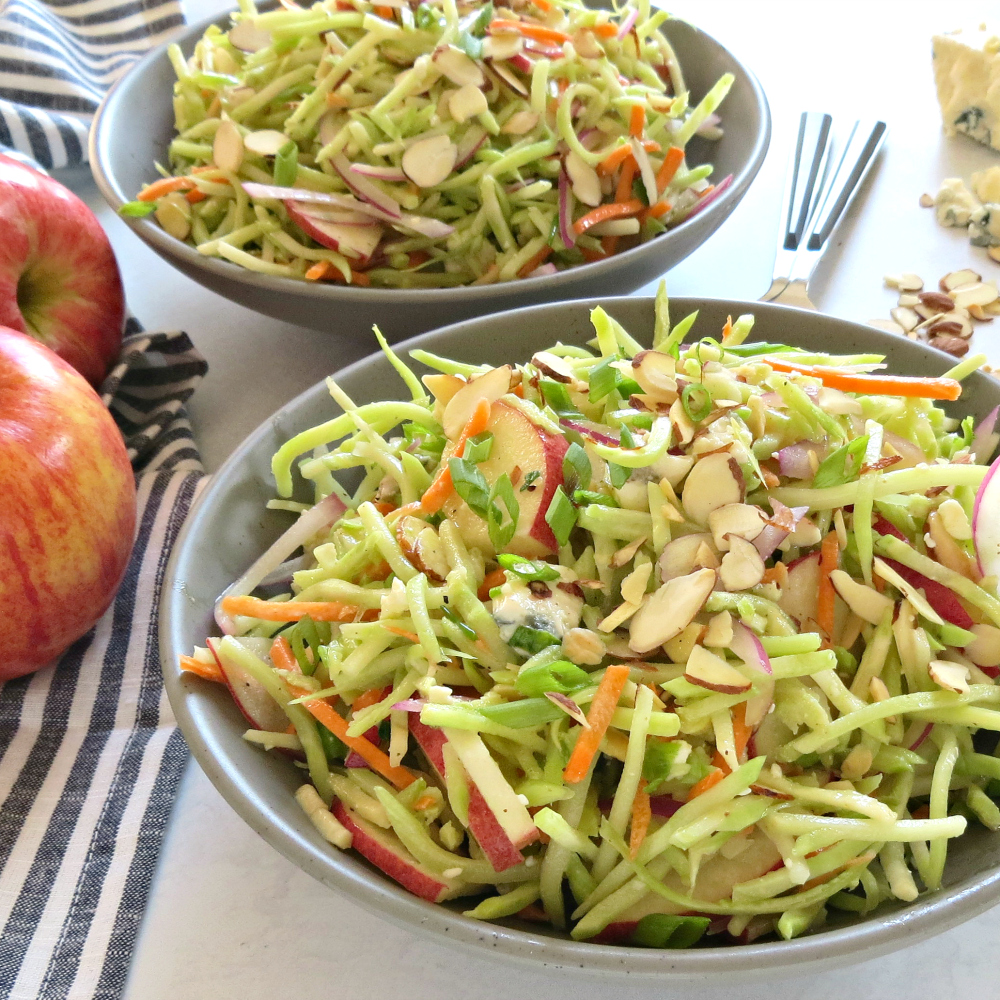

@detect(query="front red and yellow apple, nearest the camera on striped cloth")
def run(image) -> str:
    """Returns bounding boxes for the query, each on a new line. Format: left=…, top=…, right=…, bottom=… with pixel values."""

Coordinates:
left=0, top=327, right=135, bottom=679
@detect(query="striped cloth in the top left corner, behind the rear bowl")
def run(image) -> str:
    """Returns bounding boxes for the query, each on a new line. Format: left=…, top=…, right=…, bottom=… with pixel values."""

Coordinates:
left=0, top=0, right=184, bottom=168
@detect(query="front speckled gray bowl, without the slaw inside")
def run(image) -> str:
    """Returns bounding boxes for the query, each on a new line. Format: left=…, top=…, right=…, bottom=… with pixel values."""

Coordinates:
left=160, top=298, right=1000, bottom=982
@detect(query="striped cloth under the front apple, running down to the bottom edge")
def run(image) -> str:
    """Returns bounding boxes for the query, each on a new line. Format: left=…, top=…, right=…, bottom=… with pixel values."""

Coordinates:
left=0, top=322, right=206, bottom=1000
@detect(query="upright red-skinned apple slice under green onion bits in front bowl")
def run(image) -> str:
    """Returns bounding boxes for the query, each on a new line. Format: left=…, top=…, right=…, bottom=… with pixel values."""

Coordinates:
left=444, top=401, right=569, bottom=559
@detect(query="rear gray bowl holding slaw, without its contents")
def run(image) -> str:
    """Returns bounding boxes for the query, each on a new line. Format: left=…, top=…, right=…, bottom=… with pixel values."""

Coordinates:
left=90, top=6, right=771, bottom=339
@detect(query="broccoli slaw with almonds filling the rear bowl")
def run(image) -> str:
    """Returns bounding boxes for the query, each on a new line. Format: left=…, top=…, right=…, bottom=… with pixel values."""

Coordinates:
left=121, top=0, right=733, bottom=288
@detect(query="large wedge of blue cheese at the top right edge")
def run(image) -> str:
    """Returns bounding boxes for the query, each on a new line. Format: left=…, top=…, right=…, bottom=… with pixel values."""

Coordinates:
left=933, top=25, right=1000, bottom=149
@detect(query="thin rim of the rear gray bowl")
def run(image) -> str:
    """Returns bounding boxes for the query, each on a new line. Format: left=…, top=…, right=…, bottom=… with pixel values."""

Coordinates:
left=88, top=0, right=771, bottom=305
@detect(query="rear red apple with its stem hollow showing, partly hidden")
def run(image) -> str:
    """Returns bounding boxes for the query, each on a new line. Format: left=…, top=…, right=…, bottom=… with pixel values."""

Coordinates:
left=0, top=156, right=125, bottom=385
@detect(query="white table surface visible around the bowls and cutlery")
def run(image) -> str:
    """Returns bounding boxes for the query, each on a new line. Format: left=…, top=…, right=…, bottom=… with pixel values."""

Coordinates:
left=60, top=0, right=1000, bottom=1000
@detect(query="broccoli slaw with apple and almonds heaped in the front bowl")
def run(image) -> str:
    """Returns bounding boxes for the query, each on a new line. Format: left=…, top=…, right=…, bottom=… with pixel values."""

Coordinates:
left=181, top=286, right=1000, bottom=948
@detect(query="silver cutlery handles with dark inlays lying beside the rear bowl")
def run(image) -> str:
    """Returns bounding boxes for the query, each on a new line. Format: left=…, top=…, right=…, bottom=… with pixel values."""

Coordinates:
left=761, top=111, right=886, bottom=309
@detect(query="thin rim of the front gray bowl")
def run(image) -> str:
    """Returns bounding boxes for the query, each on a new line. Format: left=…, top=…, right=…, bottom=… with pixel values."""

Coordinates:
left=159, top=296, right=1000, bottom=979
